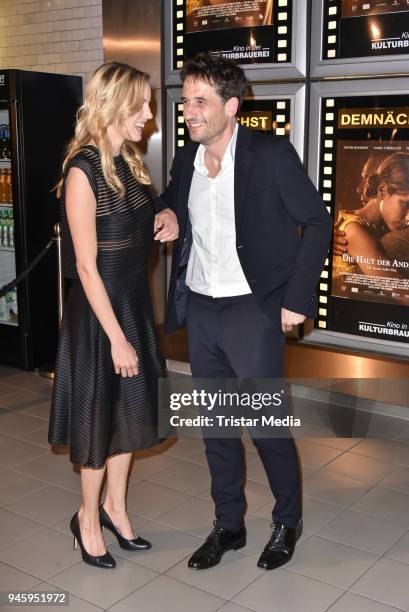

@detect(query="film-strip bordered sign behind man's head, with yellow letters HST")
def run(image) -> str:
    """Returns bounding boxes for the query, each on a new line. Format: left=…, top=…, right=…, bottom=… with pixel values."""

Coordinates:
left=174, top=98, right=291, bottom=150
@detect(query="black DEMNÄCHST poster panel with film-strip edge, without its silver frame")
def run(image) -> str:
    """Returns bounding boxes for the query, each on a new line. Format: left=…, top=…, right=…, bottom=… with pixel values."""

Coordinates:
left=320, top=96, right=409, bottom=343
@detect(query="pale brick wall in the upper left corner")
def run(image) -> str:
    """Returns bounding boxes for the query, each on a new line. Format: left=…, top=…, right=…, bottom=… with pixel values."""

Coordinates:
left=0, top=0, right=104, bottom=81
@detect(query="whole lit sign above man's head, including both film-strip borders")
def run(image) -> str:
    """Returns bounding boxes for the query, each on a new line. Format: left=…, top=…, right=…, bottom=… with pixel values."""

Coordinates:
left=173, top=0, right=293, bottom=69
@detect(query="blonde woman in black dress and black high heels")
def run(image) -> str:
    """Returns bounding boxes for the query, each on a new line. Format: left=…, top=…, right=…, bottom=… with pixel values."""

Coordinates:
left=49, top=62, right=177, bottom=568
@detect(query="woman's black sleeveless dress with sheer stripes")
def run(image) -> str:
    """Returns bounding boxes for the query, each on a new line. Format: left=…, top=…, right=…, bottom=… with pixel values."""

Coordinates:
left=48, top=145, right=165, bottom=468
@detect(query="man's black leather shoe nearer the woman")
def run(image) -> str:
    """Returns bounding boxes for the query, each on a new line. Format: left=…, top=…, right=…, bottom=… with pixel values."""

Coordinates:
left=188, top=521, right=246, bottom=569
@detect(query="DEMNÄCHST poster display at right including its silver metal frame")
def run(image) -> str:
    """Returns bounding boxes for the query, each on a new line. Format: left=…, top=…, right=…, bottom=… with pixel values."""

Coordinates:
left=306, top=78, right=409, bottom=356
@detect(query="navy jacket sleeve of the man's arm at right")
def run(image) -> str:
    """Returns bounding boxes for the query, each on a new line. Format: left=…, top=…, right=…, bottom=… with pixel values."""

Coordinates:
left=276, top=140, right=332, bottom=314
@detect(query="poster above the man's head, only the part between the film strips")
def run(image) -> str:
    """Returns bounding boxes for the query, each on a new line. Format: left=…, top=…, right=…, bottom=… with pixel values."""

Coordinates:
left=184, top=0, right=276, bottom=64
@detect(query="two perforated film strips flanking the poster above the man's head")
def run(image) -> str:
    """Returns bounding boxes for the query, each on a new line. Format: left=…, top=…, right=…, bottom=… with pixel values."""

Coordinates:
left=172, top=0, right=294, bottom=70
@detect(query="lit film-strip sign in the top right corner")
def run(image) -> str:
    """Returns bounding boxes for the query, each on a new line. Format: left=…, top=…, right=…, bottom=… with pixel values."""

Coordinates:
left=323, top=0, right=409, bottom=59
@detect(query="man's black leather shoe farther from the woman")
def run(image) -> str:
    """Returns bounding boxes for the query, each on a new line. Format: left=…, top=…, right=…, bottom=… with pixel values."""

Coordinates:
left=257, top=520, right=303, bottom=569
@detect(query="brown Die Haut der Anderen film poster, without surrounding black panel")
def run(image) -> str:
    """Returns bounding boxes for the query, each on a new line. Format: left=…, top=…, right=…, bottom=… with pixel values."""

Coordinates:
left=332, top=140, right=409, bottom=306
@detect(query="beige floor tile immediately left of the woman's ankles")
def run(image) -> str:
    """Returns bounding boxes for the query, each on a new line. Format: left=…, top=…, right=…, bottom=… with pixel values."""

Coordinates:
left=4, top=486, right=81, bottom=525
